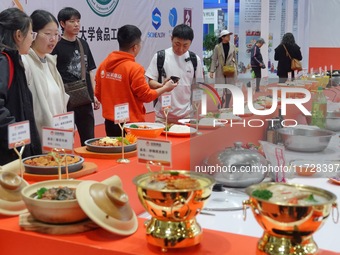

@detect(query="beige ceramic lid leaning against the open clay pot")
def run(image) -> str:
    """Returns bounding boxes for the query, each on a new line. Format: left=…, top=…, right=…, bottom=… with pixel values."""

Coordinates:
left=76, top=181, right=138, bottom=236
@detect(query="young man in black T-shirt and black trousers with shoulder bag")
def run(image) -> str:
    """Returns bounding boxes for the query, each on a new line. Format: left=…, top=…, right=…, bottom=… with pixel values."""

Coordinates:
left=52, top=7, right=100, bottom=146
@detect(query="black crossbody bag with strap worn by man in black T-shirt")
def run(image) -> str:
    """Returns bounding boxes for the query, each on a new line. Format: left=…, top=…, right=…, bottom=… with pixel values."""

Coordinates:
left=64, top=38, right=92, bottom=109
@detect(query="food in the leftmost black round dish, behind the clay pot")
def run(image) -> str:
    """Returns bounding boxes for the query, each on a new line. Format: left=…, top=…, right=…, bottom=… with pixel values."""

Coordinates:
left=24, top=153, right=80, bottom=166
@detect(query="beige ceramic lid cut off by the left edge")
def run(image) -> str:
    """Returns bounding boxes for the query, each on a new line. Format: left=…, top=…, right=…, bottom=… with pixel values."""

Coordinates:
left=0, top=171, right=28, bottom=216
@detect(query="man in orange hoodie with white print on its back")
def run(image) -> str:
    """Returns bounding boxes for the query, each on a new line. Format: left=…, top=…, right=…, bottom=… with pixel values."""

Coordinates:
left=95, top=25, right=177, bottom=136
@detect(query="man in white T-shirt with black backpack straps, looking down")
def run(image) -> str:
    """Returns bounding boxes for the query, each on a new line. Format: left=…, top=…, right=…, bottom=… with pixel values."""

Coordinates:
left=145, top=24, right=203, bottom=123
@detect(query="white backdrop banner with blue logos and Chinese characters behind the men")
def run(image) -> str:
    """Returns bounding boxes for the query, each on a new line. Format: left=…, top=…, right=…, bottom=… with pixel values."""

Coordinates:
left=0, top=0, right=203, bottom=68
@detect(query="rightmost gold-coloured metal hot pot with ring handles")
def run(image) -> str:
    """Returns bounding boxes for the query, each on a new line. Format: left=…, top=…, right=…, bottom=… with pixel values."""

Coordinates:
left=243, top=183, right=339, bottom=255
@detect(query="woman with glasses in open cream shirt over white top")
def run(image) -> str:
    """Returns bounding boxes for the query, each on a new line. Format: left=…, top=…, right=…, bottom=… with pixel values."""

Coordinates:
left=23, top=10, right=69, bottom=141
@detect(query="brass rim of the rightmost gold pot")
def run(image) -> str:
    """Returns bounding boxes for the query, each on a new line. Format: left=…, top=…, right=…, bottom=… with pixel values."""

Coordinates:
left=245, top=182, right=337, bottom=207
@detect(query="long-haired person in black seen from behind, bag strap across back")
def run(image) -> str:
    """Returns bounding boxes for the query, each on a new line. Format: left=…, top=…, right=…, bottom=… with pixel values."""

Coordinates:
left=274, top=33, right=302, bottom=83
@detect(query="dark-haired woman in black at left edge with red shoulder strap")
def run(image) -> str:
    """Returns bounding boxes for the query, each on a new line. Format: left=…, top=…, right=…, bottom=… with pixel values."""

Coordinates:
left=0, top=8, right=42, bottom=165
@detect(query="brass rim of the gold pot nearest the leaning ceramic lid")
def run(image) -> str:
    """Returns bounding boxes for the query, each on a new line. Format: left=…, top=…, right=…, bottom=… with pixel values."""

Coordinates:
left=132, top=170, right=216, bottom=192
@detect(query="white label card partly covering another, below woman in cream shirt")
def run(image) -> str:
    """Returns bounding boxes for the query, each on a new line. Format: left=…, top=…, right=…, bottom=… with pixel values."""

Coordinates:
left=42, top=127, right=73, bottom=151
